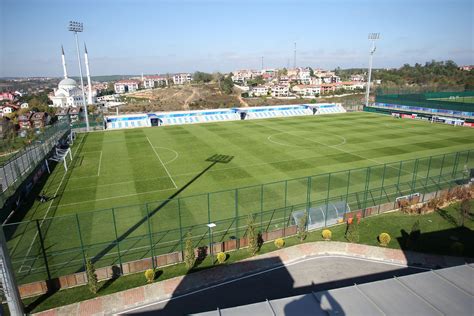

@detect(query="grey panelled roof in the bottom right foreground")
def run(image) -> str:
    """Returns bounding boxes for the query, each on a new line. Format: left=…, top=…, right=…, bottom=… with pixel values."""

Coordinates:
left=193, top=264, right=474, bottom=316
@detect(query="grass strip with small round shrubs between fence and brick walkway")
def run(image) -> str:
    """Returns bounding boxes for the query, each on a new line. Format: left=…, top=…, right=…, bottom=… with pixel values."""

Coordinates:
left=16, top=200, right=474, bottom=312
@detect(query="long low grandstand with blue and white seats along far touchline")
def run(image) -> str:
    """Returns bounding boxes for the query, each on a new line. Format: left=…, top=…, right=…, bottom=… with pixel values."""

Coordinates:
left=105, top=103, right=346, bottom=130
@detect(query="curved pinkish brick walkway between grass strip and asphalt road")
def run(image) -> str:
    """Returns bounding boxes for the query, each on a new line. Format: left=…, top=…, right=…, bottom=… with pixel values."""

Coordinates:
left=34, top=242, right=466, bottom=315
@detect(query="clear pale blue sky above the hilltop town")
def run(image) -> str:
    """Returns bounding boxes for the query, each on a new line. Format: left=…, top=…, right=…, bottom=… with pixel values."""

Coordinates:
left=0, top=0, right=474, bottom=77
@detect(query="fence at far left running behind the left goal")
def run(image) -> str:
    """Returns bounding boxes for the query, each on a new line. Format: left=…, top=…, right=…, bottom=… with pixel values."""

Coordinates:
left=0, top=121, right=70, bottom=206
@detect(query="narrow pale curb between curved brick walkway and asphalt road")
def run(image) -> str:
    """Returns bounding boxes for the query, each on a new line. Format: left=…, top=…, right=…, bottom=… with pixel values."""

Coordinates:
left=117, top=255, right=430, bottom=315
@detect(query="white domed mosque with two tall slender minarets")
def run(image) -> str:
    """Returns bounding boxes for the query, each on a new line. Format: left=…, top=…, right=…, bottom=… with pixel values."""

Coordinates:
left=49, top=46, right=94, bottom=108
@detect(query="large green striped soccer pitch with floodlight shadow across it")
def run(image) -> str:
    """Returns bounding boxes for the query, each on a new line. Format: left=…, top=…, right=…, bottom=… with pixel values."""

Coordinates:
left=6, top=112, right=474, bottom=282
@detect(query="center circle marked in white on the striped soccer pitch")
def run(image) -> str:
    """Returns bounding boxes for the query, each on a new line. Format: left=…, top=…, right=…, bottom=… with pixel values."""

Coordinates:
left=267, top=131, right=346, bottom=148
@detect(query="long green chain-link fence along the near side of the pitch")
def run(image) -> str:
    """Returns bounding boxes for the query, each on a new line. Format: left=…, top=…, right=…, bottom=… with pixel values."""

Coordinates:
left=4, top=150, right=474, bottom=283
